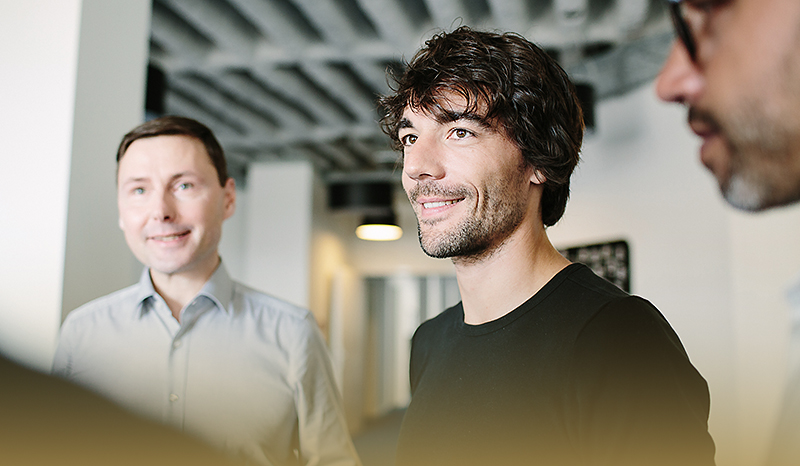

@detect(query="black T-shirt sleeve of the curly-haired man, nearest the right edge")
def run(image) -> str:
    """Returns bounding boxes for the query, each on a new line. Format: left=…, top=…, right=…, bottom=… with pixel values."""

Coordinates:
left=570, top=297, right=714, bottom=466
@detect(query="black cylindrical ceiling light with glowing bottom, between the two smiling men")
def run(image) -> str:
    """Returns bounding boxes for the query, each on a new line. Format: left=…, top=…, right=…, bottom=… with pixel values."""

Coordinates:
left=328, top=181, right=403, bottom=241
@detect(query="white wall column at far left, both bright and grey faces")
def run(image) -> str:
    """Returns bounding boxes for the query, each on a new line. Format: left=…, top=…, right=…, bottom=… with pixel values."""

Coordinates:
left=0, top=0, right=150, bottom=370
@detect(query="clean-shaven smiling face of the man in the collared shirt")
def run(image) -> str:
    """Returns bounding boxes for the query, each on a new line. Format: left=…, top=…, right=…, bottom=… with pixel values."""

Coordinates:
left=117, top=136, right=236, bottom=278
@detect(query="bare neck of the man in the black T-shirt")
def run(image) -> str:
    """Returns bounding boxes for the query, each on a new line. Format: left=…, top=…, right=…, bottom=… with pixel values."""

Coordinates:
left=453, top=222, right=570, bottom=325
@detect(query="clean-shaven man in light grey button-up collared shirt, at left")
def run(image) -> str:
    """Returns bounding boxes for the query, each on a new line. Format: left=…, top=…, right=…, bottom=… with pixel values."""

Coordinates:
left=53, top=117, right=358, bottom=465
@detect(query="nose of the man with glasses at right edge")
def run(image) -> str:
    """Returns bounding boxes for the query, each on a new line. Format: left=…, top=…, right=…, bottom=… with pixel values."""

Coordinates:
left=656, top=41, right=705, bottom=105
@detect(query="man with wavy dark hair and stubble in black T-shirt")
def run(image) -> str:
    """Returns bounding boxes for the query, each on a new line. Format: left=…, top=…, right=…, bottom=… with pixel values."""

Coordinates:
left=382, top=27, right=714, bottom=466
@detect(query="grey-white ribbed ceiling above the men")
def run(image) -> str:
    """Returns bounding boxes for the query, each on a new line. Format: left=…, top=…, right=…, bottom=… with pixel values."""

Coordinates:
left=150, top=0, right=672, bottom=181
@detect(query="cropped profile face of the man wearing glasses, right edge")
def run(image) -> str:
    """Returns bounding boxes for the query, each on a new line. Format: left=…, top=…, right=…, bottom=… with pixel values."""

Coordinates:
left=657, top=0, right=800, bottom=210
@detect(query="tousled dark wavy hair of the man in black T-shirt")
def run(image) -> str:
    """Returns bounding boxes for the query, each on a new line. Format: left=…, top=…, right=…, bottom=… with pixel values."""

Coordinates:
left=380, top=26, right=584, bottom=226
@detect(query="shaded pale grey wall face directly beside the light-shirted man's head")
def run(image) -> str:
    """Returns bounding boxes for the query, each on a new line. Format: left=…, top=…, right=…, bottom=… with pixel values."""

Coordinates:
left=62, top=0, right=151, bottom=316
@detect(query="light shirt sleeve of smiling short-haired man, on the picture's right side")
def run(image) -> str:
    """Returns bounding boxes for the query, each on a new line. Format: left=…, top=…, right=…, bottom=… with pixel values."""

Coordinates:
left=295, top=316, right=361, bottom=466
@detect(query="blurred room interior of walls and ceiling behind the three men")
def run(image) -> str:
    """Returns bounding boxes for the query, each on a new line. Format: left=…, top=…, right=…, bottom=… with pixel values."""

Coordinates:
left=0, top=0, right=800, bottom=466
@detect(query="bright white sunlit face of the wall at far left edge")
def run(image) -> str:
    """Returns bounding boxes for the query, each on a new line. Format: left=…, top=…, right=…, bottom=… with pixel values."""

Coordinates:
left=0, top=0, right=81, bottom=367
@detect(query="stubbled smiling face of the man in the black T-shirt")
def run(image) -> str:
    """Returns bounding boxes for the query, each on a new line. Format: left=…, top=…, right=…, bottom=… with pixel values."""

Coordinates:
left=398, top=97, right=540, bottom=260
